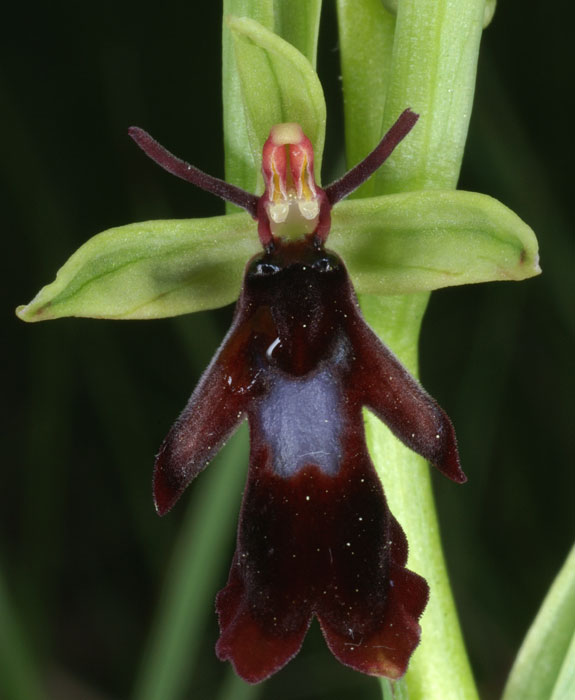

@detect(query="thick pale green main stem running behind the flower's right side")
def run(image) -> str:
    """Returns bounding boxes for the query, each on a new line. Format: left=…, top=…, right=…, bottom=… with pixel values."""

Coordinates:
left=339, top=0, right=484, bottom=700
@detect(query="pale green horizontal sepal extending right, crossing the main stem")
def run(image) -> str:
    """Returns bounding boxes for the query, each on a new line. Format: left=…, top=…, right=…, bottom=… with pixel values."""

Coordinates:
left=329, top=190, right=540, bottom=295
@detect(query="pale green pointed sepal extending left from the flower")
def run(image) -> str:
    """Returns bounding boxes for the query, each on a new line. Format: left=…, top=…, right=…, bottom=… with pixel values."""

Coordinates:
left=17, top=214, right=260, bottom=322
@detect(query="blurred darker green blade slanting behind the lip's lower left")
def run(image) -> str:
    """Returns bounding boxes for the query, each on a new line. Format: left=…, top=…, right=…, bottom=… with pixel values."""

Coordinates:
left=134, top=425, right=248, bottom=700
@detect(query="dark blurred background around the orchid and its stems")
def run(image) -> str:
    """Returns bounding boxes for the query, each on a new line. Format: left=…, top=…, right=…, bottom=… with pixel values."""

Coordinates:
left=0, top=0, right=575, bottom=700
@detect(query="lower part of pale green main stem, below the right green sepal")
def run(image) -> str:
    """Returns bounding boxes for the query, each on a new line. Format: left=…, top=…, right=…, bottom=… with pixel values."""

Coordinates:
left=362, top=294, right=477, bottom=700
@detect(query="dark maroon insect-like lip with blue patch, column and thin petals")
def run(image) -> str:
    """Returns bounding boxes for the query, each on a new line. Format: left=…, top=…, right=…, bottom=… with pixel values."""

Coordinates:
left=130, top=110, right=465, bottom=683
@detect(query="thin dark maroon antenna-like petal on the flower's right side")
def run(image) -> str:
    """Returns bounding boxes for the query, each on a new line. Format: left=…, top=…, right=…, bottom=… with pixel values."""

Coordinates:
left=325, top=109, right=419, bottom=206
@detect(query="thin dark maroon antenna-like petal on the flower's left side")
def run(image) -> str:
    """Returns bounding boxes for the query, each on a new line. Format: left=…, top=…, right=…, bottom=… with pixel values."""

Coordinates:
left=128, top=126, right=259, bottom=219
